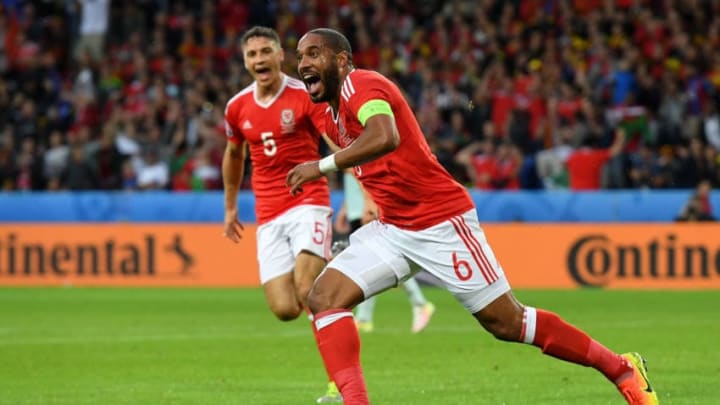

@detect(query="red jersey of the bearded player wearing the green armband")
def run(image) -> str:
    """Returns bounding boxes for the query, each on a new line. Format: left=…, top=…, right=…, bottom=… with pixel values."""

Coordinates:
left=326, top=69, right=473, bottom=230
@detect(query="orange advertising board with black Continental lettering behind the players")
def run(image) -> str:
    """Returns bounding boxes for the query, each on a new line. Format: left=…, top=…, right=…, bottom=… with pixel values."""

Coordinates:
left=0, top=223, right=720, bottom=289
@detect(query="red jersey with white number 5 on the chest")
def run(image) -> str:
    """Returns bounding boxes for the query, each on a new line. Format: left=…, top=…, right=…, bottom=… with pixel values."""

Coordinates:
left=225, top=75, right=330, bottom=224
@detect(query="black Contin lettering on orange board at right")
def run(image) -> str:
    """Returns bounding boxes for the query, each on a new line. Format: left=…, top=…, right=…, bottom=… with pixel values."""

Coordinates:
left=567, top=233, right=720, bottom=287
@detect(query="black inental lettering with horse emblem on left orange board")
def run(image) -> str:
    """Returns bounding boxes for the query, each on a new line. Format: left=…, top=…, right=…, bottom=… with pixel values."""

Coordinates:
left=0, top=232, right=195, bottom=278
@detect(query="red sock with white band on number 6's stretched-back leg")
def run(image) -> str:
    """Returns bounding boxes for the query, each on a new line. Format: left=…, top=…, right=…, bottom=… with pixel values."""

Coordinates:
left=520, top=307, right=632, bottom=384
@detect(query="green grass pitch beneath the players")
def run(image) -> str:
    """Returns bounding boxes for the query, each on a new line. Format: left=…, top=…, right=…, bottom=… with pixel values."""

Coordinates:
left=0, top=288, right=720, bottom=405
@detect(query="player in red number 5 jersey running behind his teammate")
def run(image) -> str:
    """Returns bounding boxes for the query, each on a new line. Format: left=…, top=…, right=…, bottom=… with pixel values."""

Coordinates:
left=222, top=27, right=342, bottom=403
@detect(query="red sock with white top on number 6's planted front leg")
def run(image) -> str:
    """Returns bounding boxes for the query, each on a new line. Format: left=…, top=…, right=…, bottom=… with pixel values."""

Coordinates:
left=314, top=309, right=370, bottom=405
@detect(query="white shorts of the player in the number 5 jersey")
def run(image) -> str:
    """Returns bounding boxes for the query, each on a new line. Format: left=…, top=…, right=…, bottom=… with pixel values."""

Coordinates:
left=257, top=205, right=332, bottom=284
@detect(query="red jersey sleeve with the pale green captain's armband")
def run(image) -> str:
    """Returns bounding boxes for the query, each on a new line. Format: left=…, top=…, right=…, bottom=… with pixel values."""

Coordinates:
left=341, top=76, right=394, bottom=127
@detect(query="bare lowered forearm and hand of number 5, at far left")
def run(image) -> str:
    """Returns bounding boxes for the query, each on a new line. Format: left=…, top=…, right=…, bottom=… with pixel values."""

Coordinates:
left=222, top=142, right=245, bottom=243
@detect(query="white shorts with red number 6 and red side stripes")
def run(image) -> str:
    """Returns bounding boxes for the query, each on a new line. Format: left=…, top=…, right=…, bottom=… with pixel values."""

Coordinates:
left=326, top=209, right=510, bottom=313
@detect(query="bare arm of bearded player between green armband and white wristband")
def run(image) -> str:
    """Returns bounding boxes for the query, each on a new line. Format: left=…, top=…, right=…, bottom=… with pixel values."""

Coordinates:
left=335, top=114, right=400, bottom=169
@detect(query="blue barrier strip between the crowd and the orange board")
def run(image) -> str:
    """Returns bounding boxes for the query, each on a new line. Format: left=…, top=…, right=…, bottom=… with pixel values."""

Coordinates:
left=0, top=190, right=720, bottom=223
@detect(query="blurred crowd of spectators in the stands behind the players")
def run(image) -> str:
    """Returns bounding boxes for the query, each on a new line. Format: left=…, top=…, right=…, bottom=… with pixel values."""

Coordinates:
left=0, top=0, right=720, bottom=191
